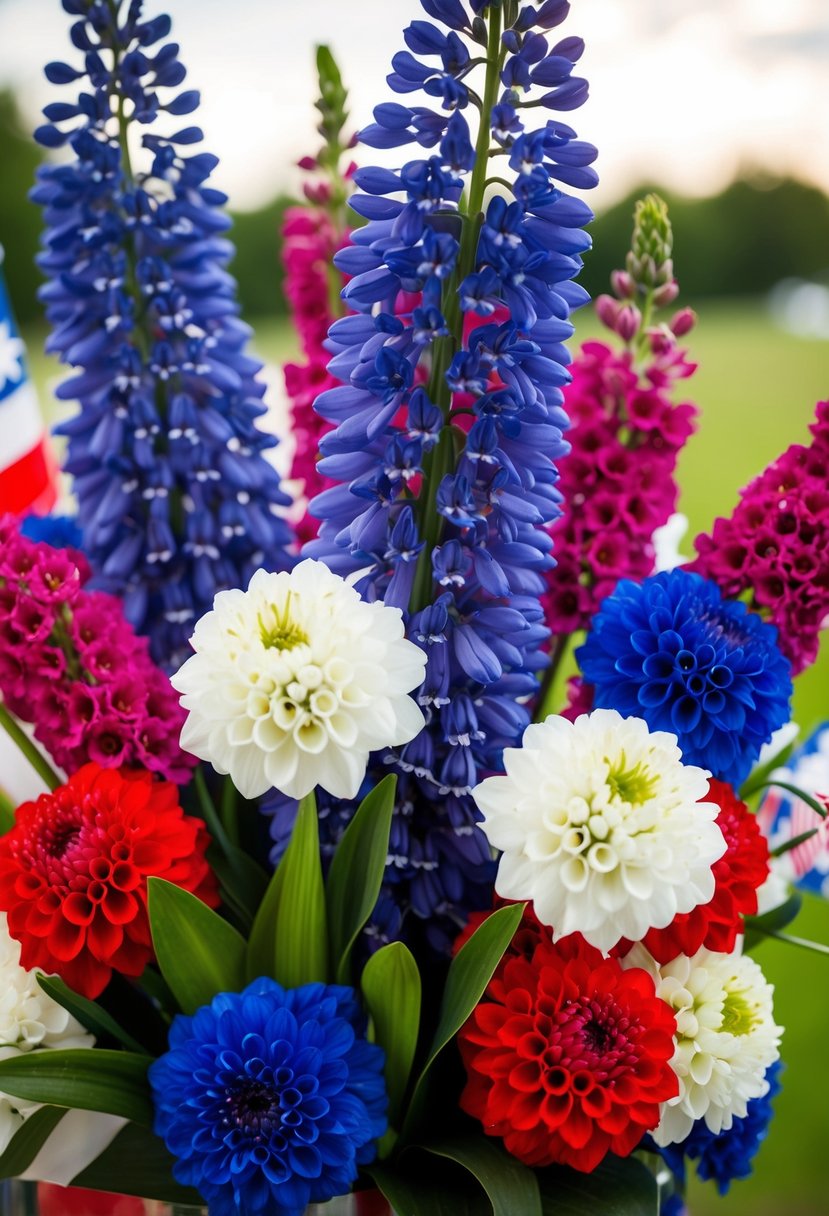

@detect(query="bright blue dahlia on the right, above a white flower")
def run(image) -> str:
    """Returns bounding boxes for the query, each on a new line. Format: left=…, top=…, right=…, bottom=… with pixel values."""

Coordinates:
left=576, top=569, right=791, bottom=787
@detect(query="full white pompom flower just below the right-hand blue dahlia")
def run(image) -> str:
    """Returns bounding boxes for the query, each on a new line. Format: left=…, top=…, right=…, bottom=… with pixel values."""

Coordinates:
left=473, top=709, right=726, bottom=952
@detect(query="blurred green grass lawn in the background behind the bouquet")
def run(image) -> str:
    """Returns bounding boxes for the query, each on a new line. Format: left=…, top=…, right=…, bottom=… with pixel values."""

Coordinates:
left=27, top=300, right=829, bottom=1216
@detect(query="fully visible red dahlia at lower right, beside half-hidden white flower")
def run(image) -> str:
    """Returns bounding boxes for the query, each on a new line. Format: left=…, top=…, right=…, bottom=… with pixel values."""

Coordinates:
left=458, top=935, right=678, bottom=1172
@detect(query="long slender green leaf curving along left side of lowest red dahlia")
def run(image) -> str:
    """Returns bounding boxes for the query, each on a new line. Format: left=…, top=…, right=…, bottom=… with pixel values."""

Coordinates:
left=402, top=903, right=525, bottom=1137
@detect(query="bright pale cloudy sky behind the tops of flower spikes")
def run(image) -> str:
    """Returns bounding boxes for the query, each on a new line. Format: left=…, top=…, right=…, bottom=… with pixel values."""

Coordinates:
left=0, top=0, right=829, bottom=208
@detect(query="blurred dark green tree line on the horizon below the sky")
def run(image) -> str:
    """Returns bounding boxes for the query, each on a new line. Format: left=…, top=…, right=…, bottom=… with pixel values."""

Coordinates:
left=0, top=91, right=829, bottom=325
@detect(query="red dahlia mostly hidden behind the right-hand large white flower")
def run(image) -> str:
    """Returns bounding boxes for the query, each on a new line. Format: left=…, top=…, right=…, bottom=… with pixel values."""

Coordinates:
left=627, top=779, right=768, bottom=963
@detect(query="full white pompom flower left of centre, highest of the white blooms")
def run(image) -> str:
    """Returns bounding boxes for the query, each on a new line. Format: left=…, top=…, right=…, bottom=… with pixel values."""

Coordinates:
left=171, top=558, right=425, bottom=798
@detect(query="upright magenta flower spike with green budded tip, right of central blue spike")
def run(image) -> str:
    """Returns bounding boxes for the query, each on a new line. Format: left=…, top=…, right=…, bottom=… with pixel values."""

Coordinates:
left=546, top=195, right=697, bottom=635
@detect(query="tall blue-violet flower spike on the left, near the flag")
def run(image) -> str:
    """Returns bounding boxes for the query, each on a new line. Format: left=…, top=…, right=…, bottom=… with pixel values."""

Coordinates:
left=33, top=0, right=291, bottom=666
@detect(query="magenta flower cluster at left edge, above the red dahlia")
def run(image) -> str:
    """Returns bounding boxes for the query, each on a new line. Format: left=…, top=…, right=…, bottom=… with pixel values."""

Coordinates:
left=0, top=516, right=196, bottom=783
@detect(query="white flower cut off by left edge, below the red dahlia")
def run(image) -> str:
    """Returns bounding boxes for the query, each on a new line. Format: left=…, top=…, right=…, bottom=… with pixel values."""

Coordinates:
left=0, top=912, right=95, bottom=1154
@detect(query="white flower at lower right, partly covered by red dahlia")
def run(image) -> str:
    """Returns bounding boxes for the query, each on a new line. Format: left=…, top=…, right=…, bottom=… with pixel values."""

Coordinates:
left=622, top=946, right=783, bottom=1144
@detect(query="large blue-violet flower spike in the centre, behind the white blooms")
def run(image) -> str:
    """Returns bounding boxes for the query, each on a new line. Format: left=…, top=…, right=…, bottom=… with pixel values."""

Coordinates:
left=273, top=0, right=597, bottom=938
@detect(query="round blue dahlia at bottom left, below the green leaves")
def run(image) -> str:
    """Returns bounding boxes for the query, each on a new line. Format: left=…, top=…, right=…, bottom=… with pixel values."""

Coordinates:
left=150, top=979, right=387, bottom=1216
